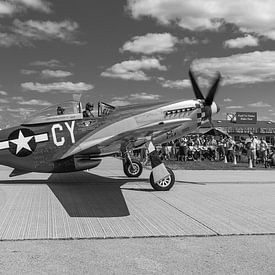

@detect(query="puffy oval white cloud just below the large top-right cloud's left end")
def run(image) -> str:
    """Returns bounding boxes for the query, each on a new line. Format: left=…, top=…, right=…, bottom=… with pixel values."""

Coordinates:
left=120, top=33, right=179, bottom=54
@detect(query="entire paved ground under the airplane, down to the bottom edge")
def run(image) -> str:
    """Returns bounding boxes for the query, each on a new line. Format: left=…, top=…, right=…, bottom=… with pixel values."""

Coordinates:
left=0, top=158, right=275, bottom=274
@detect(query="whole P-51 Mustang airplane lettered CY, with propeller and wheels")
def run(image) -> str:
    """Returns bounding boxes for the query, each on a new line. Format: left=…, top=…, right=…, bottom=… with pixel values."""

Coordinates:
left=0, top=71, right=220, bottom=191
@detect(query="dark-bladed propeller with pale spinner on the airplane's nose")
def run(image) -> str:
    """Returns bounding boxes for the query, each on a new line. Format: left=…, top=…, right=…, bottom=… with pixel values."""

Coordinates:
left=189, top=70, right=221, bottom=127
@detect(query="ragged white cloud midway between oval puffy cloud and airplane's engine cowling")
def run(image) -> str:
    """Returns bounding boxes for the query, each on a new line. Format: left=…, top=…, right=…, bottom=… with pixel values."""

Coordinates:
left=101, top=57, right=167, bottom=81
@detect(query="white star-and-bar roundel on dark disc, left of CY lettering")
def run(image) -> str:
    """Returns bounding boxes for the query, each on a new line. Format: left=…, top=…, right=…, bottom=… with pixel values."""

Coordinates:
left=0, top=128, right=49, bottom=157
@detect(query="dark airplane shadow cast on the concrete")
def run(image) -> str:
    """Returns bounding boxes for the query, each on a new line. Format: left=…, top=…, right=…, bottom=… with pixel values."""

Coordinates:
left=0, top=172, right=151, bottom=218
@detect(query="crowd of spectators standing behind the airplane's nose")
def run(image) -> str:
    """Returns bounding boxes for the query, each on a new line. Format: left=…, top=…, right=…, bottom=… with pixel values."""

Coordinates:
left=157, top=133, right=275, bottom=167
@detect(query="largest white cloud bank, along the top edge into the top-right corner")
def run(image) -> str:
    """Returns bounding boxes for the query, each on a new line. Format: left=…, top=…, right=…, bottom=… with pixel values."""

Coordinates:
left=127, top=0, right=275, bottom=39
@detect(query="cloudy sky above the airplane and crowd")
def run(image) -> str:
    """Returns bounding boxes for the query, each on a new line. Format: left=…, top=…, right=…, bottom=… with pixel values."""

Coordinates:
left=0, top=0, right=275, bottom=128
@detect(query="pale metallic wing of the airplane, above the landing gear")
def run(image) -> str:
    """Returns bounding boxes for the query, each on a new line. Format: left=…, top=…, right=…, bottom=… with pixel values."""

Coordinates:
left=60, top=118, right=192, bottom=159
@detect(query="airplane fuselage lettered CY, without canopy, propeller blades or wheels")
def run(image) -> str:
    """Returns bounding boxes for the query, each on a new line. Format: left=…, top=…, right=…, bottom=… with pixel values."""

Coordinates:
left=0, top=100, right=220, bottom=172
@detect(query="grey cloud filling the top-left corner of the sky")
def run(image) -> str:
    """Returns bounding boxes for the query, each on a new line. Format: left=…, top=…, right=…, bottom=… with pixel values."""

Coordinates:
left=0, top=0, right=52, bottom=17
